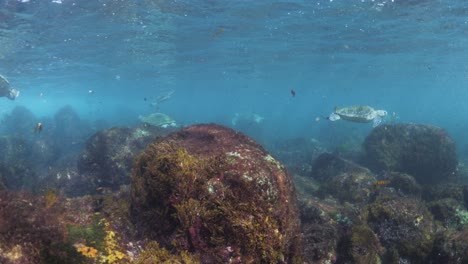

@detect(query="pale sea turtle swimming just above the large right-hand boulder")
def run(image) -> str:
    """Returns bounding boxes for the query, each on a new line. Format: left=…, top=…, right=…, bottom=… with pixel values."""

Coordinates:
left=328, top=105, right=387, bottom=127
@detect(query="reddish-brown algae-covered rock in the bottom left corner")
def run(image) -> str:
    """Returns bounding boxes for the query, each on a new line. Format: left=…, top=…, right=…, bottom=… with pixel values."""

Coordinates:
left=0, top=191, right=66, bottom=264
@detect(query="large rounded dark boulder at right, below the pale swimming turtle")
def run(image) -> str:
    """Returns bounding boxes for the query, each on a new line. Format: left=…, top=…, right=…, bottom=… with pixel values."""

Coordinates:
left=364, top=124, right=458, bottom=184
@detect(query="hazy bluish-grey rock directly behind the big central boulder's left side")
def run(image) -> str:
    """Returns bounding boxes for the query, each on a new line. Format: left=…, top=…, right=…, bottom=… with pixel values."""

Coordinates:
left=77, top=124, right=172, bottom=193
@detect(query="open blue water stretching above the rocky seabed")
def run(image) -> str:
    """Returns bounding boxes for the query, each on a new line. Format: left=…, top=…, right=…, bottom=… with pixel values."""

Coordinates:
left=0, top=0, right=468, bottom=154
